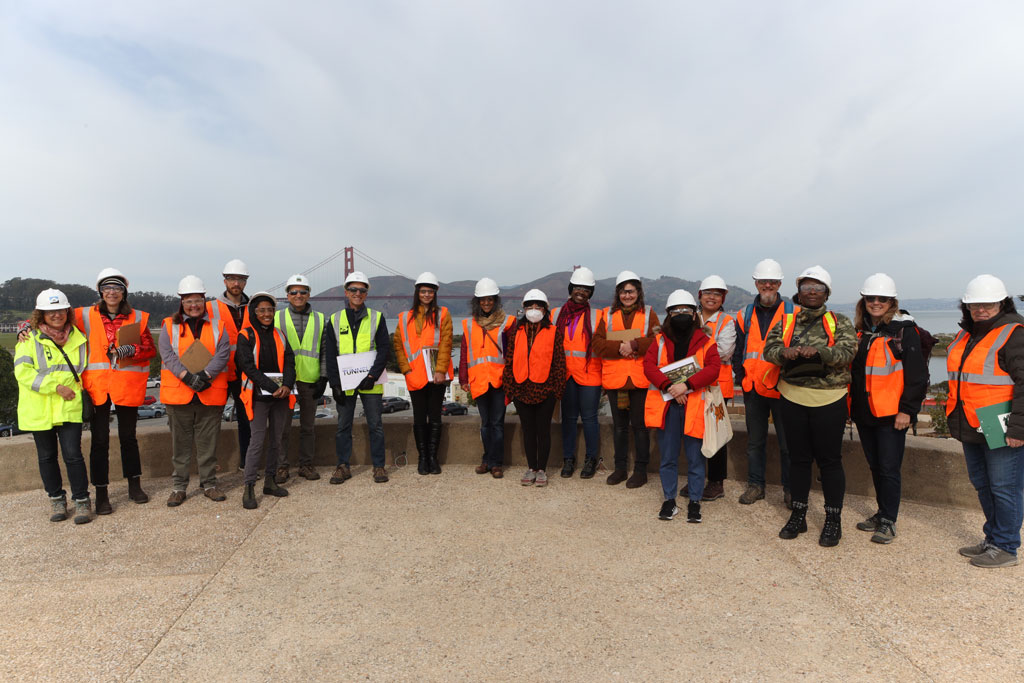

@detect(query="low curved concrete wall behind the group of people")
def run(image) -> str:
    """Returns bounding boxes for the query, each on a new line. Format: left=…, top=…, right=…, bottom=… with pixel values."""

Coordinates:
left=0, top=415, right=978, bottom=508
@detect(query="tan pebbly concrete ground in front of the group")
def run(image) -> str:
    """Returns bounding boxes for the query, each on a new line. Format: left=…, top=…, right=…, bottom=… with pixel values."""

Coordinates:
left=0, top=465, right=1024, bottom=682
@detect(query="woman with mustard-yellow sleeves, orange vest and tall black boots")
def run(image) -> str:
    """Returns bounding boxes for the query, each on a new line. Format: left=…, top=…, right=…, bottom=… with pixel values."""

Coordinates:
left=392, top=271, right=455, bottom=474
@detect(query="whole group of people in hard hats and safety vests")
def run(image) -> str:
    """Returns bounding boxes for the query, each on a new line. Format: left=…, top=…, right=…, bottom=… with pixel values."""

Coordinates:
left=14, top=259, right=1024, bottom=567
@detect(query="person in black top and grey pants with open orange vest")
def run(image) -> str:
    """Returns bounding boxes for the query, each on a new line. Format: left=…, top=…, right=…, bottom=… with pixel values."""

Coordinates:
left=234, top=292, right=295, bottom=510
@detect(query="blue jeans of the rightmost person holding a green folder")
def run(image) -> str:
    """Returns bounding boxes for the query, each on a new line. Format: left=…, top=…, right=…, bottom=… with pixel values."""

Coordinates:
left=963, top=443, right=1024, bottom=555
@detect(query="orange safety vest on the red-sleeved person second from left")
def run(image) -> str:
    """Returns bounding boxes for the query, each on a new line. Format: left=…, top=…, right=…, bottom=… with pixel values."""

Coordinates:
left=75, top=306, right=150, bottom=408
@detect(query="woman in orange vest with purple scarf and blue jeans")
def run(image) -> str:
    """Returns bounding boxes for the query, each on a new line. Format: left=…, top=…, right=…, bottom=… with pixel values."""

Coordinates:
left=551, top=267, right=601, bottom=479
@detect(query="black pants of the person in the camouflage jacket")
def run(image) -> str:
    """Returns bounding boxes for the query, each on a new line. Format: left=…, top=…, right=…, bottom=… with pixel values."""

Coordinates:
left=781, top=396, right=847, bottom=508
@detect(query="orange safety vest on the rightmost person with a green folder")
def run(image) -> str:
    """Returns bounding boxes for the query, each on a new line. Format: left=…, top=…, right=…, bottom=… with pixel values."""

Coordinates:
left=946, top=323, right=1024, bottom=428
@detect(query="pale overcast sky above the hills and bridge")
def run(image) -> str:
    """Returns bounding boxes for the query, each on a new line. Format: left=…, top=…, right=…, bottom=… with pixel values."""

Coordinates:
left=0, top=0, right=1024, bottom=301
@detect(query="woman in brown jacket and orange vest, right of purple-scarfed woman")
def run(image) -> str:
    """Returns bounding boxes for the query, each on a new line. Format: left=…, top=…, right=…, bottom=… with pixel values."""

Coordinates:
left=593, top=270, right=658, bottom=488
